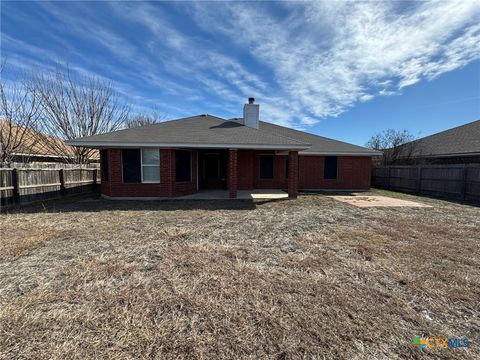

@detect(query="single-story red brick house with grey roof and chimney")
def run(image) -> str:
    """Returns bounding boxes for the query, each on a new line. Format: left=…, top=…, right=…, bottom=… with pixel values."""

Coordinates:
left=67, top=98, right=381, bottom=198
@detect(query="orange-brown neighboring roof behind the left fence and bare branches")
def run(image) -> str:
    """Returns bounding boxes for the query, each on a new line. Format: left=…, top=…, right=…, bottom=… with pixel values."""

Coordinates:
left=0, top=120, right=99, bottom=159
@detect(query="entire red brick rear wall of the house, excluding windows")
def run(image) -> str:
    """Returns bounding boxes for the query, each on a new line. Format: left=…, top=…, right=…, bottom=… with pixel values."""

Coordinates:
left=101, top=149, right=371, bottom=197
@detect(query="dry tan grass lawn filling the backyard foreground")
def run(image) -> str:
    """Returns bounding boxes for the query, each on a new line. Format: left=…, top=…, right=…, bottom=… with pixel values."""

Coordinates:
left=0, top=192, right=480, bottom=359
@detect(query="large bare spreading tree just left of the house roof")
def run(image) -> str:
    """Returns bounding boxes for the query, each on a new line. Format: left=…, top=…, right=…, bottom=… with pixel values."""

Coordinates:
left=31, top=66, right=129, bottom=164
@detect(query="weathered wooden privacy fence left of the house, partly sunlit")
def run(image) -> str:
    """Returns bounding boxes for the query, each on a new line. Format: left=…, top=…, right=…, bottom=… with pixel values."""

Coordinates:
left=0, top=168, right=99, bottom=205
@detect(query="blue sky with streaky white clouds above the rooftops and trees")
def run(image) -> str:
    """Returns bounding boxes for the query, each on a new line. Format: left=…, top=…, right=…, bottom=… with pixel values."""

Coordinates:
left=0, top=1, right=480, bottom=145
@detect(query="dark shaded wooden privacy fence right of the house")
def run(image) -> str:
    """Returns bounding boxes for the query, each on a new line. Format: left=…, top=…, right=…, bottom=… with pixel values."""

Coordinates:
left=372, top=164, right=480, bottom=201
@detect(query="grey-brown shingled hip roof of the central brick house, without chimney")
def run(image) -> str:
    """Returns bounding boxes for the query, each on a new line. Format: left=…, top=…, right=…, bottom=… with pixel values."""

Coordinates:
left=67, top=115, right=379, bottom=156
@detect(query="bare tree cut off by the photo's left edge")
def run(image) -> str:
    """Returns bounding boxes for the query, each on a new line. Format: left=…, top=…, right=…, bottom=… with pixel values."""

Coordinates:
left=0, top=61, right=41, bottom=166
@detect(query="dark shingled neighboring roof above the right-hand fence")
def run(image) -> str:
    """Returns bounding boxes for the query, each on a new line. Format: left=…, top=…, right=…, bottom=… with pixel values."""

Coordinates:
left=402, top=120, right=480, bottom=157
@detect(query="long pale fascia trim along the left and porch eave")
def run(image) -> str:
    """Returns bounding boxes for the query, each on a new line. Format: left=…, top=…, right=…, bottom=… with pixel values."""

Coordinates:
left=65, top=140, right=311, bottom=150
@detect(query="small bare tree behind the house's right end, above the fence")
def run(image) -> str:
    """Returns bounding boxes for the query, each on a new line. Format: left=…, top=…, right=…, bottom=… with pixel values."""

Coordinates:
left=366, top=129, right=415, bottom=165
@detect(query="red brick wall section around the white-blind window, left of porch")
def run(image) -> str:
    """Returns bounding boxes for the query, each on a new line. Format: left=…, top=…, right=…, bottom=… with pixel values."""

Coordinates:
left=101, top=149, right=197, bottom=197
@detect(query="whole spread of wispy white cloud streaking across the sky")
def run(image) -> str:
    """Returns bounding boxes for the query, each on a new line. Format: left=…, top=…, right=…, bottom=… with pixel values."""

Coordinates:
left=2, top=1, right=480, bottom=127
